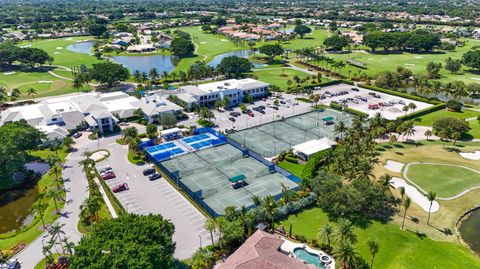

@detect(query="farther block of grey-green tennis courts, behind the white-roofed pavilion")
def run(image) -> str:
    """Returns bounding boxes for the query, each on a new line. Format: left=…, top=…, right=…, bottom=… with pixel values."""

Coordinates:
left=229, top=109, right=352, bottom=157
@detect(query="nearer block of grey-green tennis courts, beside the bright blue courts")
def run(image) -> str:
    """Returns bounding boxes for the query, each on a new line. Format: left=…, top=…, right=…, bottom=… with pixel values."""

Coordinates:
left=162, top=144, right=298, bottom=215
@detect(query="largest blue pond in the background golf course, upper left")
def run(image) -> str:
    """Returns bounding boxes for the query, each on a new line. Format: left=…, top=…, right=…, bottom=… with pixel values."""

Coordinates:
left=112, top=55, right=176, bottom=74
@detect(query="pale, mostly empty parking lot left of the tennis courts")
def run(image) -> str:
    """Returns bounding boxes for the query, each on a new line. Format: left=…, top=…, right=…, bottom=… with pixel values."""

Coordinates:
left=97, top=142, right=215, bottom=259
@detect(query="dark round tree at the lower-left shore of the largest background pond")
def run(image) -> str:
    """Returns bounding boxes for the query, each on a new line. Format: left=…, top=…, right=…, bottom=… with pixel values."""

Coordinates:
left=90, top=62, right=130, bottom=88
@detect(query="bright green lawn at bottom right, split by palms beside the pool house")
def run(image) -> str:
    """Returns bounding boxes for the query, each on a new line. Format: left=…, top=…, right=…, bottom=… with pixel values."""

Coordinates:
left=281, top=208, right=480, bottom=269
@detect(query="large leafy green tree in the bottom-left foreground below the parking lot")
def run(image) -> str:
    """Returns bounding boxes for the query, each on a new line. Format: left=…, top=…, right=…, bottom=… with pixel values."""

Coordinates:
left=70, top=214, right=175, bottom=269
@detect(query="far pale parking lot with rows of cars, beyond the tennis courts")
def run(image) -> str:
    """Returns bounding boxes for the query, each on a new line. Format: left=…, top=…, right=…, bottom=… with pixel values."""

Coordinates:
left=315, top=84, right=432, bottom=120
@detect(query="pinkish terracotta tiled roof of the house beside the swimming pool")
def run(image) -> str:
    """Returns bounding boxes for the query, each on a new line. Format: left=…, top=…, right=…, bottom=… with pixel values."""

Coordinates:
left=215, top=230, right=318, bottom=269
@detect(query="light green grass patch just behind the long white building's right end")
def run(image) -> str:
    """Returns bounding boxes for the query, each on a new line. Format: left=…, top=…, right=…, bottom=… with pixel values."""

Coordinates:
left=254, top=67, right=316, bottom=91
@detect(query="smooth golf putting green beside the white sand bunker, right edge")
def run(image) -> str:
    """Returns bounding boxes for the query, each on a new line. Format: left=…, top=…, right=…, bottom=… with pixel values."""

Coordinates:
left=407, top=161, right=480, bottom=198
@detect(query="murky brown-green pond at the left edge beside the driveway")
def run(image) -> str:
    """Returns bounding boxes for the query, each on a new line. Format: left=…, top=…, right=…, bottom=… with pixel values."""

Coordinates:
left=0, top=186, right=38, bottom=234
